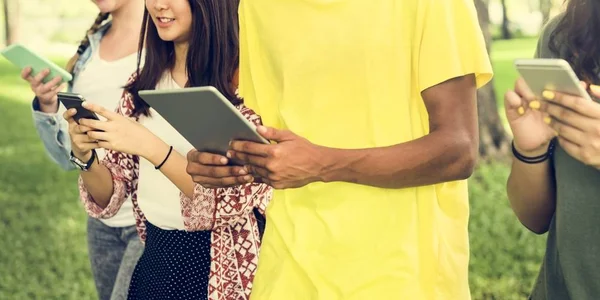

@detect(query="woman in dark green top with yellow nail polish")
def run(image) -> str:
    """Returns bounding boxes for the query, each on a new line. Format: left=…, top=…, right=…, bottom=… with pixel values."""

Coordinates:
left=505, top=0, right=600, bottom=300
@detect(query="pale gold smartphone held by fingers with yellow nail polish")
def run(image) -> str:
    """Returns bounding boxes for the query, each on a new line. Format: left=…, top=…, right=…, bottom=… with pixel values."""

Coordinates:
left=515, top=58, right=592, bottom=101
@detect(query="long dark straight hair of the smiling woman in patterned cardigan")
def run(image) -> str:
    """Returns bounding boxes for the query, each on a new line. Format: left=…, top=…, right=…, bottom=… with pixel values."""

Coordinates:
left=125, top=0, right=241, bottom=116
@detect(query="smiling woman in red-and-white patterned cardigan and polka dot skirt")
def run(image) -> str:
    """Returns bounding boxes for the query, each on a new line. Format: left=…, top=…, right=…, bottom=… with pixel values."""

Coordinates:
left=65, top=0, right=270, bottom=300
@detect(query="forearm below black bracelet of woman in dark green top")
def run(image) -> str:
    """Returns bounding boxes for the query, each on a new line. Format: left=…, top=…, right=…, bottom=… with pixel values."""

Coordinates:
left=507, top=159, right=556, bottom=234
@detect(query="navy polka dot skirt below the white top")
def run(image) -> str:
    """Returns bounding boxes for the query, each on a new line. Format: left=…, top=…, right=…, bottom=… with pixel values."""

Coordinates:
left=127, top=222, right=211, bottom=300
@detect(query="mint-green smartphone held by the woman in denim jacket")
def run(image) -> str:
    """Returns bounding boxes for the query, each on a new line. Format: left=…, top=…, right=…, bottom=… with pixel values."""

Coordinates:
left=0, top=44, right=73, bottom=83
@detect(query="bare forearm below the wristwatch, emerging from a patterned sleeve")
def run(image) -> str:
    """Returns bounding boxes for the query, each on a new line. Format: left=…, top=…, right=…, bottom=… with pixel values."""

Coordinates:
left=81, top=158, right=114, bottom=208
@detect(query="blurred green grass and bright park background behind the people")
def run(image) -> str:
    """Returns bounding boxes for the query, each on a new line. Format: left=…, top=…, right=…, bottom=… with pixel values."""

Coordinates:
left=0, top=0, right=559, bottom=300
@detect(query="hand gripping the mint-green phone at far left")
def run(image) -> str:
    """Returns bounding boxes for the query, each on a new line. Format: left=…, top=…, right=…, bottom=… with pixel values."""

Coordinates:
left=21, top=67, right=68, bottom=113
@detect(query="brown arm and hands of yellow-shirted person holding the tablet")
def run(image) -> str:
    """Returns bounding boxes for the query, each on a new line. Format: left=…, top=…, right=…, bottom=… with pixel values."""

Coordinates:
left=204, top=75, right=479, bottom=189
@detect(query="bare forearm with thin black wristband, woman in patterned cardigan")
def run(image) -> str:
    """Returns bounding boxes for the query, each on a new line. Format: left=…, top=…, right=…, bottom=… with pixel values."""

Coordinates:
left=144, top=140, right=194, bottom=198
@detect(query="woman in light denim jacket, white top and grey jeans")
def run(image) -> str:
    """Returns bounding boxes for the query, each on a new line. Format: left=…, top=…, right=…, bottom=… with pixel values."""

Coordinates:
left=22, top=0, right=144, bottom=300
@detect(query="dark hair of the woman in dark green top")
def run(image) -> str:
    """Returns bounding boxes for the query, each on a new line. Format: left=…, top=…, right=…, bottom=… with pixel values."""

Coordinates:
left=549, top=0, right=600, bottom=83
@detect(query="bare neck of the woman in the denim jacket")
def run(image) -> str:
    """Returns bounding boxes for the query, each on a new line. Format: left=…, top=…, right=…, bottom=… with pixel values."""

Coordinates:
left=110, top=0, right=144, bottom=35
